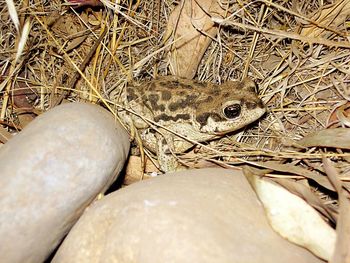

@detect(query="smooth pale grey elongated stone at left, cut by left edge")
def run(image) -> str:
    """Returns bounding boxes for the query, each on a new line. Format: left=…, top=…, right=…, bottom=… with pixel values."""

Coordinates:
left=0, top=103, right=130, bottom=263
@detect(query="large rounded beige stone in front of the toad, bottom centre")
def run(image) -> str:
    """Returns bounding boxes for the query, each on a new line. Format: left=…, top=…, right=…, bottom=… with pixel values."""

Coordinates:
left=53, top=169, right=323, bottom=263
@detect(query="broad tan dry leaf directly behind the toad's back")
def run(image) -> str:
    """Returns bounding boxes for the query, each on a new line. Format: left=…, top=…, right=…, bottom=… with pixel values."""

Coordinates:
left=165, top=0, right=226, bottom=79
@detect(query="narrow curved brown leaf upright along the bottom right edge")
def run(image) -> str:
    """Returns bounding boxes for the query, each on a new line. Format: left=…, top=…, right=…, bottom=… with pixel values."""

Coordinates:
left=322, top=158, right=350, bottom=263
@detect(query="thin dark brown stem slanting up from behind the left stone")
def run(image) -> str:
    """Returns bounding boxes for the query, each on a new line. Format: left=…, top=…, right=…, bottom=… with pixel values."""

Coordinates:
left=52, top=28, right=108, bottom=107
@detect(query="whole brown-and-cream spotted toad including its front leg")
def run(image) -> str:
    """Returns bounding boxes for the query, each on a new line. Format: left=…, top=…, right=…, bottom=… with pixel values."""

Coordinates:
left=119, top=76, right=266, bottom=171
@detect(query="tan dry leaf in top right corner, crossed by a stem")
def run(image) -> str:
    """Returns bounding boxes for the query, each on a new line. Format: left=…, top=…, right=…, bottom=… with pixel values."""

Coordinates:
left=300, top=0, right=350, bottom=38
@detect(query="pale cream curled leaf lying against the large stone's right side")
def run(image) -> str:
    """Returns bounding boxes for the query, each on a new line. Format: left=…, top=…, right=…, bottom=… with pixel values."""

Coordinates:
left=243, top=167, right=336, bottom=260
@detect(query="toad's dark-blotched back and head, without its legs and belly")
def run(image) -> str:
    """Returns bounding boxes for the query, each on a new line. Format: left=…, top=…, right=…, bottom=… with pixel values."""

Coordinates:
left=126, top=76, right=265, bottom=134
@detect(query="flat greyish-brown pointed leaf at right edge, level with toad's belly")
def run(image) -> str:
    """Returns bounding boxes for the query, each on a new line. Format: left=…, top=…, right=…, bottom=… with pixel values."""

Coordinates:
left=298, top=128, right=350, bottom=149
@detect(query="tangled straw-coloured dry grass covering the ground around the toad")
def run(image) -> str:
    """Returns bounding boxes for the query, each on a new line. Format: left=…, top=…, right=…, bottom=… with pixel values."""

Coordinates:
left=0, top=0, right=350, bottom=185
